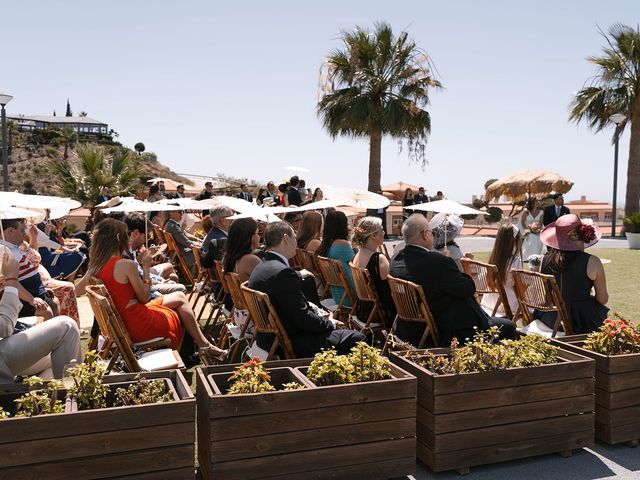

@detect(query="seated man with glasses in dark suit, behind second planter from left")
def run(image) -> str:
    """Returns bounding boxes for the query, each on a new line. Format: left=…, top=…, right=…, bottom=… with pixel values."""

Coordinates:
left=249, top=222, right=365, bottom=358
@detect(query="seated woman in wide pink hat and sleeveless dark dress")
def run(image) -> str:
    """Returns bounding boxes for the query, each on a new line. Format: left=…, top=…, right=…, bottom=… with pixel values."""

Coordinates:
left=534, top=214, right=609, bottom=334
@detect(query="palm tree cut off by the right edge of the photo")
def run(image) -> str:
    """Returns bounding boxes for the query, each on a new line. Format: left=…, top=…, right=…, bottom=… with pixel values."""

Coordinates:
left=569, top=24, right=640, bottom=216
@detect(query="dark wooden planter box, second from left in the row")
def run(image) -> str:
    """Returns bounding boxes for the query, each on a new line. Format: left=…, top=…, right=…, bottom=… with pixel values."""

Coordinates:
left=196, top=359, right=416, bottom=480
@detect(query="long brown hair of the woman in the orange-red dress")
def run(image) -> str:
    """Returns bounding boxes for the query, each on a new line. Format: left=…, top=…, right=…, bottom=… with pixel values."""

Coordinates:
left=87, top=218, right=129, bottom=276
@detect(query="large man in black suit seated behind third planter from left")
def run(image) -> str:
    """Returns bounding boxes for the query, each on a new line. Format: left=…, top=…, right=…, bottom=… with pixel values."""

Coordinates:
left=390, top=213, right=515, bottom=346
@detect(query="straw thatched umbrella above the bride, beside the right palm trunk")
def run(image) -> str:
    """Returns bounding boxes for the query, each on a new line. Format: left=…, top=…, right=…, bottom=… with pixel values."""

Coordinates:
left=484, top=170, right=573, bottom=202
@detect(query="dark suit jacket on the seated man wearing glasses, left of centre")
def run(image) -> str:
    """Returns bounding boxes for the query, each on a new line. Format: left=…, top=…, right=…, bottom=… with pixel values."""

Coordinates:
left=249, top=252, right=334, bottom=353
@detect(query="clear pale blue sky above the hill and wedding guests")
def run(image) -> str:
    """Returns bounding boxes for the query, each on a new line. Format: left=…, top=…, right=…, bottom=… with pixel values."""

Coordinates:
left=0, top=0, right=640, bottom=203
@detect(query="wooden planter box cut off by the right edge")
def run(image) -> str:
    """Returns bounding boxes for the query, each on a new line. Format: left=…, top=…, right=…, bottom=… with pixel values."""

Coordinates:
left=554, top=335, right=640, bottom=446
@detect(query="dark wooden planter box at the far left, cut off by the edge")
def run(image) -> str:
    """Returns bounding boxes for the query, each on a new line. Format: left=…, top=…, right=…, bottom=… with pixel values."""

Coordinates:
left=0, top=370, right=195, bottom=480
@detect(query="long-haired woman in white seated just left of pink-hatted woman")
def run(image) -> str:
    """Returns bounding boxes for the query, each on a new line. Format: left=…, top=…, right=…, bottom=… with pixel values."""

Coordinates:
left=480, top=225, right=522, bottom=317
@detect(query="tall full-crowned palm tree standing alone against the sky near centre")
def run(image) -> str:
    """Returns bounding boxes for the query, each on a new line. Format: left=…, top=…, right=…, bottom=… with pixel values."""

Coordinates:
left=317, top=23, right=441, bottom=192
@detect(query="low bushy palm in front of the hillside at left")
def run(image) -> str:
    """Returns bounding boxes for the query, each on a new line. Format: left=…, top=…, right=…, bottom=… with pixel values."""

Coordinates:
left=49, top=146, right=141, bottom=204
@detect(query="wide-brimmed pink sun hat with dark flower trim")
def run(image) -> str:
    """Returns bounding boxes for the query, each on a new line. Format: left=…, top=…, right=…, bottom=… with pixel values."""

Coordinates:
left=540, top=213, right=602, bottom=252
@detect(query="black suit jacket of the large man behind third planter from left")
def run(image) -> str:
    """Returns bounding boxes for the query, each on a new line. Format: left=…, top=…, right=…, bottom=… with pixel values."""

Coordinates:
left=391, top=245, right=488, bottom=347
